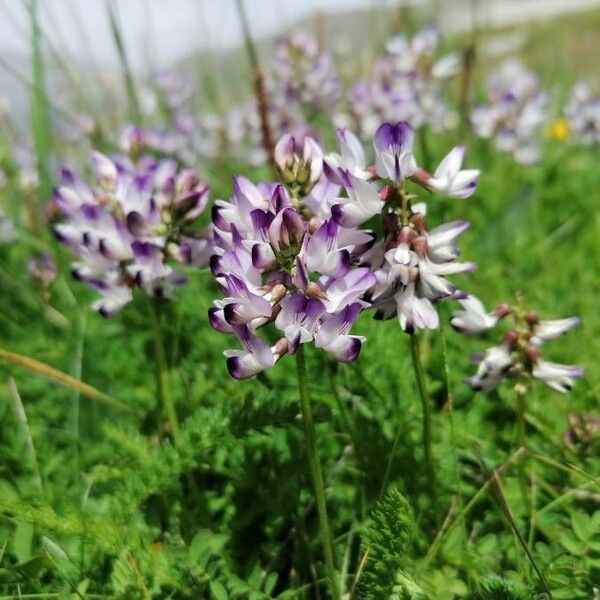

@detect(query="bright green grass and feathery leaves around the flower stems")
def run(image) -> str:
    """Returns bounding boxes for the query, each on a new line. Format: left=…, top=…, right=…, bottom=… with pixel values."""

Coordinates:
left=0, top=4, right=600, bottom=600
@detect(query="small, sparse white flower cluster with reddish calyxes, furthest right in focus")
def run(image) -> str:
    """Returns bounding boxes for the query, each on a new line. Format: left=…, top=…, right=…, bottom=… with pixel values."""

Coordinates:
left=451, top=296, right=583, bottom=393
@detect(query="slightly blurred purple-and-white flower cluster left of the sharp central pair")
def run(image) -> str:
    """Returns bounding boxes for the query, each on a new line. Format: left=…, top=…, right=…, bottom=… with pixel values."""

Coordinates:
left=53, top=152, right=212, bottom=316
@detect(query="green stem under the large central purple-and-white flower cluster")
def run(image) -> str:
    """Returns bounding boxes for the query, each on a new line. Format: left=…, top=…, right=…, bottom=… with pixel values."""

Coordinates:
left=296, top=346, right=341, bottom=600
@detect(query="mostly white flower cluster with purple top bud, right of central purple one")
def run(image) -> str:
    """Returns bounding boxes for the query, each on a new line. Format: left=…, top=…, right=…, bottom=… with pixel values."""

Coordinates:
left=326, top=122, right=479, bottom=333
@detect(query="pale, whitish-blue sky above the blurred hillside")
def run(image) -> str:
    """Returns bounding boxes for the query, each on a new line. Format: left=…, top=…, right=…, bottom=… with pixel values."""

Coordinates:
left=0, top=0, right=384, bottom=69
